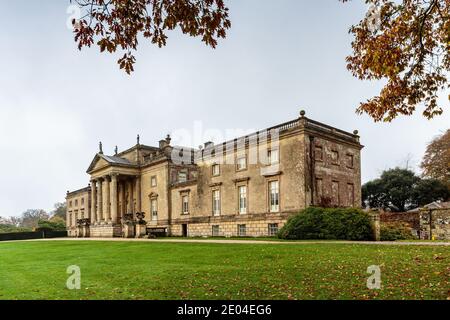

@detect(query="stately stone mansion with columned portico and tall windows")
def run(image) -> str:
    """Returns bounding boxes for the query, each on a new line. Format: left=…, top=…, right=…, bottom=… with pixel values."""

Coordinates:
left=66, top=111, right=362, bottom=237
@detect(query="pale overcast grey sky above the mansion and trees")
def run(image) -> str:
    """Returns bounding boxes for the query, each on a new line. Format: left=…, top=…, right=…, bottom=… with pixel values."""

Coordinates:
left=0, top=0, right=450, bottom=216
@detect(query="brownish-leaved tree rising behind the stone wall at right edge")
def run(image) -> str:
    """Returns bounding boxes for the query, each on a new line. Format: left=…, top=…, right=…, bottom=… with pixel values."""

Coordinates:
left=421, top=129, right=450, bottom=188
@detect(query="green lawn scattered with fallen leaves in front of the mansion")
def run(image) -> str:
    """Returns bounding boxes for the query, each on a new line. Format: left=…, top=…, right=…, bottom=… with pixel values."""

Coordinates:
left=0, top=241, right=450, bottom=299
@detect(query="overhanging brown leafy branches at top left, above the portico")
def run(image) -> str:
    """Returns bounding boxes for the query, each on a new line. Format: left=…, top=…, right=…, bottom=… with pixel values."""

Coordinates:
left=70, top=0, right=231, bottom=74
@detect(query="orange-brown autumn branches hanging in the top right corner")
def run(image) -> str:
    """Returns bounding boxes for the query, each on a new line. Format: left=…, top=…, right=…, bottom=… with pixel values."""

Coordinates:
left=341, top=0, right=450, bottom=121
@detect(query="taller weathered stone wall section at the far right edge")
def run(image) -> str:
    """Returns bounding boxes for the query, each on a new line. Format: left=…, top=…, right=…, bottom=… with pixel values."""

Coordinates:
left=420, top=209, right=450, bottom=240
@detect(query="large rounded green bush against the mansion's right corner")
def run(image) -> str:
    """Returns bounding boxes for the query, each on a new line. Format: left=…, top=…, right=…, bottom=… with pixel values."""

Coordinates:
left=278, top=207, right=374, bottom=240
